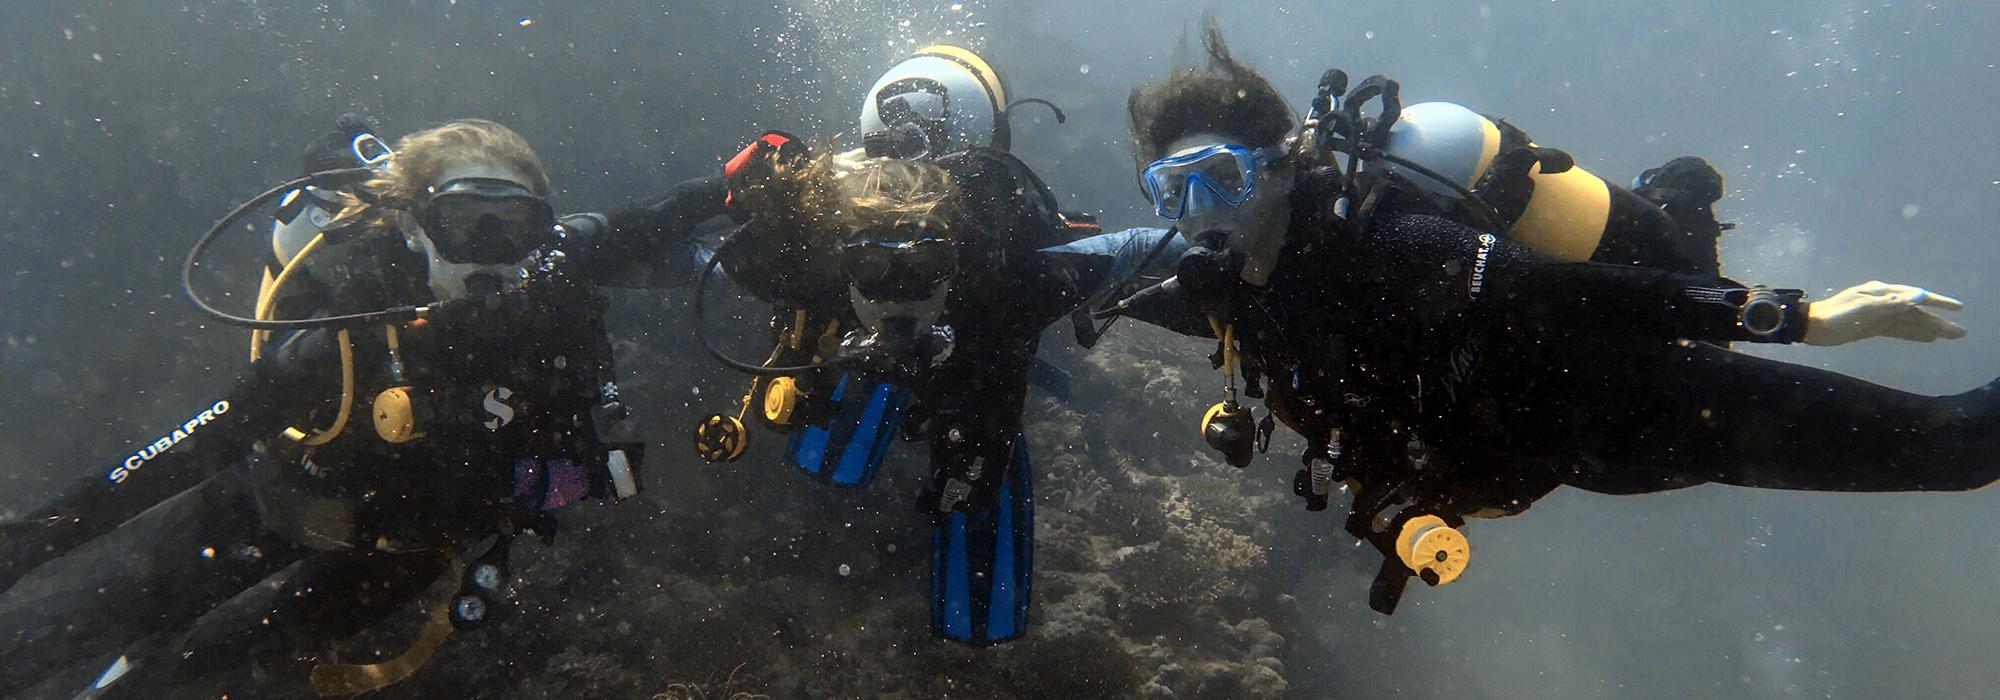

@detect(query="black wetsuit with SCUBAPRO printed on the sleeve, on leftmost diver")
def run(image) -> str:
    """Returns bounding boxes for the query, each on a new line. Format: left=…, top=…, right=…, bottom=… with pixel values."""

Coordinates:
left=0, top=180, right=720, bottom=692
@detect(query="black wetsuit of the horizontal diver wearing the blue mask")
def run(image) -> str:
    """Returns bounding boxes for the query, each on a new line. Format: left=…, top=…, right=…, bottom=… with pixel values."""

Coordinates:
left=1176, top=191, right=2000, bottom=514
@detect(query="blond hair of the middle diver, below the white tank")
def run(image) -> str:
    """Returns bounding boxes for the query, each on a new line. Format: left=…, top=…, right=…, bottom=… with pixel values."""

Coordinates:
left=734, top=152, right=954, bottom=246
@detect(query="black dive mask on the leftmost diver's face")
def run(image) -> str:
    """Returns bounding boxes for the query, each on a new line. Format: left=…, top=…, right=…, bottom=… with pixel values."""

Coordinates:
left=422, top=178, right=556, bottom=264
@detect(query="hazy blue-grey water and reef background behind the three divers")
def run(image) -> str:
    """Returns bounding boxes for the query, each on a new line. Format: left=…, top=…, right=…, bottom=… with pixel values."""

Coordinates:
left=0, top=0, right=2000, bottom=698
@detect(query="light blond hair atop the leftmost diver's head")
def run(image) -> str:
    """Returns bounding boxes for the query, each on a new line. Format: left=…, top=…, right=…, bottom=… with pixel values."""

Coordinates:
left=334, top=120, right=552, bottom=226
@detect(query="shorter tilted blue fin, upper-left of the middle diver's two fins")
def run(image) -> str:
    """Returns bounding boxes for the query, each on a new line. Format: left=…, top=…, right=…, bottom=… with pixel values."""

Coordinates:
left=784, top=374, right=910, bottom=486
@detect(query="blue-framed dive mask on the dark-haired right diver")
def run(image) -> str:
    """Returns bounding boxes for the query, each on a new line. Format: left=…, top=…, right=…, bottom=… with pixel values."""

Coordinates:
left=1140, top=144, right=1284, bottom=222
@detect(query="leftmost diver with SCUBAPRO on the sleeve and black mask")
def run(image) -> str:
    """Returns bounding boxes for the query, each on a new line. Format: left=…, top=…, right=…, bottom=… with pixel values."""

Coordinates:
left=0, top=120, right=720, bottom=696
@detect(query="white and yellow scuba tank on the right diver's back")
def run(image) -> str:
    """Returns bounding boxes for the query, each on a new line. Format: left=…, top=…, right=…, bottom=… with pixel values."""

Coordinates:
left=1364, top=102, right=1612, bottom=262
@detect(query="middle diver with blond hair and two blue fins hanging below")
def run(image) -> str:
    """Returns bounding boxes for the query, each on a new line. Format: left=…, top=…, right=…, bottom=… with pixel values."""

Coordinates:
left=696, top=46, right=1098, bottom=644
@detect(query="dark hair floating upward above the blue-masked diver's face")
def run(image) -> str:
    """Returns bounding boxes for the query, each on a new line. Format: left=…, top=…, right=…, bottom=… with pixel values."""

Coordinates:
left=1126, top=14, right=1298, bottom=168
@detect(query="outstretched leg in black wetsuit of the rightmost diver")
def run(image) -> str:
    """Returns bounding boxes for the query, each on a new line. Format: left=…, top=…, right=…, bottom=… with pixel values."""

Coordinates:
left=1540, top=342, right=2000, bottom=492
